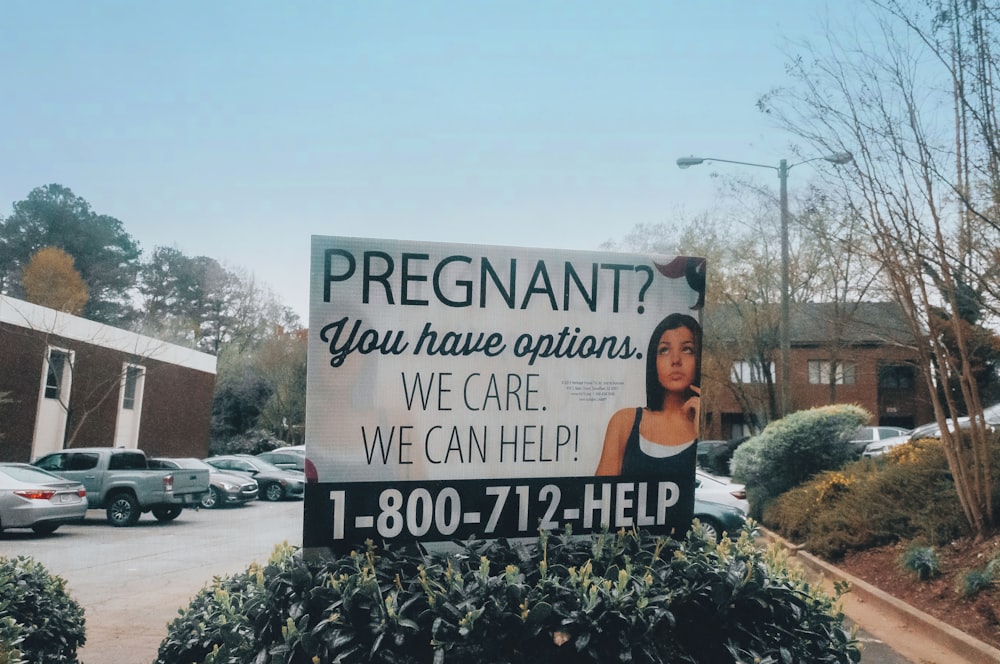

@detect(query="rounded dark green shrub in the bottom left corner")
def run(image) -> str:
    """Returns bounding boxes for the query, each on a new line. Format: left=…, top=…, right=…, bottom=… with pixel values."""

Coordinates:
left=0, top=556, right=87, bottom=664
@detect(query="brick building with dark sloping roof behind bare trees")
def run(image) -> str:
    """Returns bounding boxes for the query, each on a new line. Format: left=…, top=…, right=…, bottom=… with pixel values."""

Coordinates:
left=702, top=302, right=934, bottom=440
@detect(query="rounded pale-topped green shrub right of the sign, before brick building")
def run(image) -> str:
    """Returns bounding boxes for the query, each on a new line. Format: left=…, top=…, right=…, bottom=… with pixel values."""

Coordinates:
left=730, top=405, right=871, bottom=520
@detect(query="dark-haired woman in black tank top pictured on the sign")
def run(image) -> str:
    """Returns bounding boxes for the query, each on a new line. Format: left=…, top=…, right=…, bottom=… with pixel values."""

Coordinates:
left=596, top=314, right=701, bottom=477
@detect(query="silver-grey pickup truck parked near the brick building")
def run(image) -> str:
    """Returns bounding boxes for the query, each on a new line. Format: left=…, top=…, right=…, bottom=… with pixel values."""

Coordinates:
left=33, top=447, right=209, bottom=526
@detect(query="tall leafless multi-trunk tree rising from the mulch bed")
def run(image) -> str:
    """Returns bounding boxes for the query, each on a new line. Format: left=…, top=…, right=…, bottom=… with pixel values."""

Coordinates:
left=761, top=0, right=1000, bottom=537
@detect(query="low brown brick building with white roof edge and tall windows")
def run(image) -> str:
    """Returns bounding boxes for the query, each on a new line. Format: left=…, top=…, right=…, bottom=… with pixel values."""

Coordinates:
left=0, top=295, right=215, bottom=461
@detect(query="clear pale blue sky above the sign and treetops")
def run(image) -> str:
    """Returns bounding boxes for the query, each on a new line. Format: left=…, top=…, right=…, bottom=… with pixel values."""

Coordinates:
left=0, top=0, right=861, bottom=319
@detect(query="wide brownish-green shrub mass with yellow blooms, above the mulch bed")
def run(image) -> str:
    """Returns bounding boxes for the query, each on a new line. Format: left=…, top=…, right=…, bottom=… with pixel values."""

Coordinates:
left=762, top=440, right=970, bottom=560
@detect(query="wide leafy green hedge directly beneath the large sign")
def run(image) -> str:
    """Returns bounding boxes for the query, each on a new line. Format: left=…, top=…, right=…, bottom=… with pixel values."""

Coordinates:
left=157, top=526, right=860, bottom=664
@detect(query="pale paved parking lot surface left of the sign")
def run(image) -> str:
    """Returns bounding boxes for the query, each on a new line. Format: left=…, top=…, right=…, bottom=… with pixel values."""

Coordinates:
left=0, top=500, right=302, bottom=664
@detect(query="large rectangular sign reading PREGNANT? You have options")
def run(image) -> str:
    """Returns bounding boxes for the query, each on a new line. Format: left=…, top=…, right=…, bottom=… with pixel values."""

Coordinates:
left=303, top=236, right=705, bottom=551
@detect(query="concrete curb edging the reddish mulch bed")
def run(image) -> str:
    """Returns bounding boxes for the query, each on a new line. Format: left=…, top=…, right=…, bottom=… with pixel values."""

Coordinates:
left=758, top=526, right=1000, bottom=664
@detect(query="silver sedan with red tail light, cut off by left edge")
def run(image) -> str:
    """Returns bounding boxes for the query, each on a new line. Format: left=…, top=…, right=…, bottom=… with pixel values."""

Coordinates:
left=0, top=463, right=87, bottom=535
